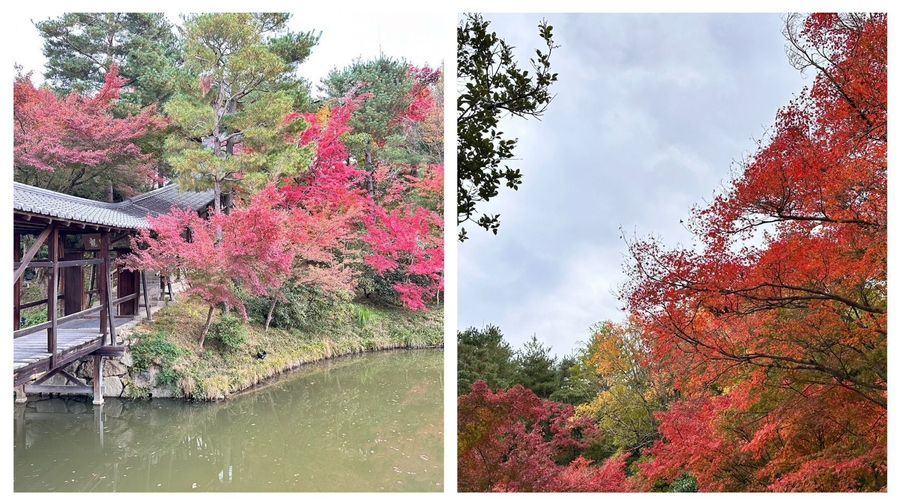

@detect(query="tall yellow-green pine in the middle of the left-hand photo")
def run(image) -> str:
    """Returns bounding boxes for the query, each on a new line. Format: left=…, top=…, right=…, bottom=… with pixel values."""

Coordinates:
left=166, top=13, right=318, bottom=210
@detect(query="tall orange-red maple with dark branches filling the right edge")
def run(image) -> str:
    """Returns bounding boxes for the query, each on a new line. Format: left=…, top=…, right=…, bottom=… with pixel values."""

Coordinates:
left=625, top=14, right=887, bottom=491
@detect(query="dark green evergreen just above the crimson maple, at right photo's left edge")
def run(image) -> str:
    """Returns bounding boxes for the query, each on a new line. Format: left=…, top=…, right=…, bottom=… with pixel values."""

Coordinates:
left=456, top=325, right=516, bottom=395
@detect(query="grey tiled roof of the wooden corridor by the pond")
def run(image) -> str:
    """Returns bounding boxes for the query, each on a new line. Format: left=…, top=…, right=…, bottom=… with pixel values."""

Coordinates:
left=13, top=182, right=214, bottom=229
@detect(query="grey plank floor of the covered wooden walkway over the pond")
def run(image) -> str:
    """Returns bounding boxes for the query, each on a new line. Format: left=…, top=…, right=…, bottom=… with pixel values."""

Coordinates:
left=13, top=317, right=134, bottom=385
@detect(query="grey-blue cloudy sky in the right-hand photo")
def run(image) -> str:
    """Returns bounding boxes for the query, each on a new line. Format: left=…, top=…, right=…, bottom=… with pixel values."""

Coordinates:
left=459, top=14, right=810, bottom=356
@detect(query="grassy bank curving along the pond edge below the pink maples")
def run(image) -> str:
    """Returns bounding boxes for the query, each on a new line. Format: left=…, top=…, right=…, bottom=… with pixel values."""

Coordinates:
left=126, top=300, right=444, bottom=400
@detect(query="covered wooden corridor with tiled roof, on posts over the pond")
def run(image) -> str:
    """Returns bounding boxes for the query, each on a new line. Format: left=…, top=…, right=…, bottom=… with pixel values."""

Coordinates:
left=13, top=183, right=212, bottom=404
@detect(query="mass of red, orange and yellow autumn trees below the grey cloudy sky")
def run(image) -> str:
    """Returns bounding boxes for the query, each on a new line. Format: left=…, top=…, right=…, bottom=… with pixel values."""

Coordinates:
left=459, top=10, right=887, bottom=492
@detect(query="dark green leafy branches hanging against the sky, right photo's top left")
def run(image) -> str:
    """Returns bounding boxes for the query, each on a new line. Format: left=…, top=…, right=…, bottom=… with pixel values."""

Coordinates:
left=456, top=14, right=557, bottom=240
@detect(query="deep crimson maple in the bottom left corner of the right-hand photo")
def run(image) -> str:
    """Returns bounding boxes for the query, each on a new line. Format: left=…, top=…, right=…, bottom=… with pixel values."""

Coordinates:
left=457, top=381, right=631, bottom=492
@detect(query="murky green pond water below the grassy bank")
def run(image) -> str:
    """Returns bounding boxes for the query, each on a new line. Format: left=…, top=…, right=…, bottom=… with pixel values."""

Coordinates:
left=14, top=350, right=444, bottom=492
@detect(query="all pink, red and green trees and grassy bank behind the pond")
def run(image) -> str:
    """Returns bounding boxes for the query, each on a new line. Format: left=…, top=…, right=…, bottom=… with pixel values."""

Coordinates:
left=14, top=13, right=444, bottom=406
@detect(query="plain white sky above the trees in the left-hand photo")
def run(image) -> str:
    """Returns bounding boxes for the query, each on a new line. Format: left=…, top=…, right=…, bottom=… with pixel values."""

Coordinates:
left=9, top=10, right=449, bottom=91
